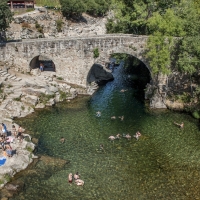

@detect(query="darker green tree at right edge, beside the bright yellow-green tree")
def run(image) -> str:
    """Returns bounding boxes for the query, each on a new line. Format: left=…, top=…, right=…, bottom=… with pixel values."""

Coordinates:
left=177, top=0, right=200, bottom=74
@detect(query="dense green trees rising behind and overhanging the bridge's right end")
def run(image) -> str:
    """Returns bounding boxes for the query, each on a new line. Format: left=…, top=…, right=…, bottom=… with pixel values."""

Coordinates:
left=107, top=0, right=200, bottom=74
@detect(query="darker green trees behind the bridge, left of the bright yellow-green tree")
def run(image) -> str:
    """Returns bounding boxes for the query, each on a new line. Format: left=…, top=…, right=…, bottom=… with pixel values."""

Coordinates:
left=107, top=0, right=179, bottom=35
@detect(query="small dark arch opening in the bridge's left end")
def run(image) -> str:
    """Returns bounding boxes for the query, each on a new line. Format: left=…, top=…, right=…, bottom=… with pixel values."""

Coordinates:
left=30, top=55, right=56, bottom=72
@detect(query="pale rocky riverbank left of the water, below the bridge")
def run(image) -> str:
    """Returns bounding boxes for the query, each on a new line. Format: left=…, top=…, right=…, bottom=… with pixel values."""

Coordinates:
left=0, top=61, right=86, bottom=195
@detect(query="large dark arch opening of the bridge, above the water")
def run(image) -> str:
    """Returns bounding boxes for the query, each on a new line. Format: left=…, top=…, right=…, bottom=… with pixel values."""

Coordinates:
left=87, top=53, right=152, bottom=101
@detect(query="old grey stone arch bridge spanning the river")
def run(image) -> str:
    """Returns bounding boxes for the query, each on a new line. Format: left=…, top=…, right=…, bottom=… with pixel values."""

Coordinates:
left=0, top=34, right=168, bottom=107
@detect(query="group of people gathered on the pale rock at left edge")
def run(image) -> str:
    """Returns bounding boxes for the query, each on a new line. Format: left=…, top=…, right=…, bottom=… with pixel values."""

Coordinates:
left=0, top=123, right=25, bottom=157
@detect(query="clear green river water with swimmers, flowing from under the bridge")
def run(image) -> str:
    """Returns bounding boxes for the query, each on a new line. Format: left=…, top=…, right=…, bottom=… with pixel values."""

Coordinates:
left=11, top=64, right=200, bottom=200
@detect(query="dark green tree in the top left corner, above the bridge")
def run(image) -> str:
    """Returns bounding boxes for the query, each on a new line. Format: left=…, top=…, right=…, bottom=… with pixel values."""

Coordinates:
left=0, top=0, right=13, bottom=31
